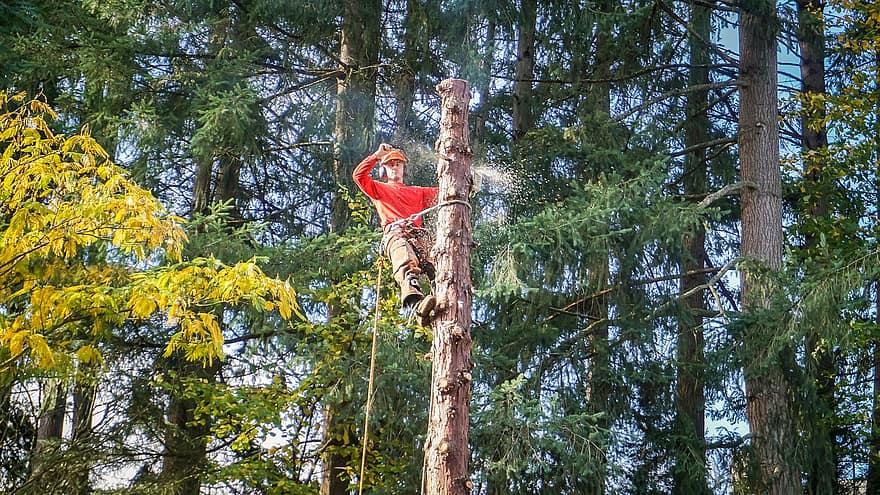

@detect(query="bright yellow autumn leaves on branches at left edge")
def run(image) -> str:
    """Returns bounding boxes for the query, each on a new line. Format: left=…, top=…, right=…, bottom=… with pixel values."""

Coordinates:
left=0, top=92, right=302, bottom=373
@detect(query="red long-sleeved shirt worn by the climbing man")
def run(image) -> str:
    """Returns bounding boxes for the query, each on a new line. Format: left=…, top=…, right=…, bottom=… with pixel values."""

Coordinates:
left=352, top=154, right=438, bottom=227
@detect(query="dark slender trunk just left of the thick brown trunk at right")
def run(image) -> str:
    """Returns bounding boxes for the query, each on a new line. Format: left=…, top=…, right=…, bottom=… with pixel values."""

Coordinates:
left=672, top=1, right=712, bottom=495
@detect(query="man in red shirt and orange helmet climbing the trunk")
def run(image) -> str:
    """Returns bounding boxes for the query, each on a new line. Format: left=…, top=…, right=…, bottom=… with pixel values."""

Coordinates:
left=352, top=143, right=438, bottom=326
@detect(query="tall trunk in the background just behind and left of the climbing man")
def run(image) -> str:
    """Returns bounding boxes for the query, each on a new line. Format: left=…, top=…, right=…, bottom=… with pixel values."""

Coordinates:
left=320, top=0, right=382, bottom=495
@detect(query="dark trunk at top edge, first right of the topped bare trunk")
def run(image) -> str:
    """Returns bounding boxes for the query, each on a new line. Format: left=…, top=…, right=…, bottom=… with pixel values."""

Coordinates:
left=513, top=0, right=538, bottom=144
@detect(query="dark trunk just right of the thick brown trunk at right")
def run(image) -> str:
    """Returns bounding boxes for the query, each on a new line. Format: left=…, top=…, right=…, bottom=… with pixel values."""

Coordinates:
left=797, top=0, right=837, bottom=494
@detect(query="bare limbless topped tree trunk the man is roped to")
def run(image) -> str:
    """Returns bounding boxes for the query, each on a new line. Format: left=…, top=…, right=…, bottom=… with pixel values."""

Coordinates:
left=425, top=79, right=473, bottom=495
